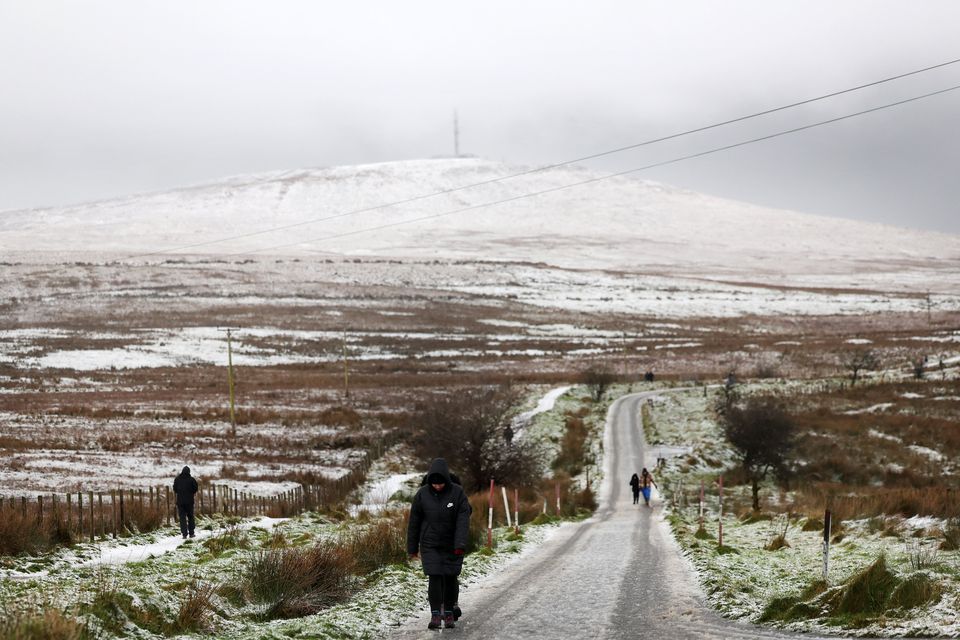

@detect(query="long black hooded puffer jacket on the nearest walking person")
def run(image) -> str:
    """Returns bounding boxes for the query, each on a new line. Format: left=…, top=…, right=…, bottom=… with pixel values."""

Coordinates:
left=407, top=458, right=470, bottom=575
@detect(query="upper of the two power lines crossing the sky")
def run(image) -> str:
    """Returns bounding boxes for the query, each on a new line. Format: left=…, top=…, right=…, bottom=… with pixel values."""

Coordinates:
left=127, top=58, right=960, bottom=259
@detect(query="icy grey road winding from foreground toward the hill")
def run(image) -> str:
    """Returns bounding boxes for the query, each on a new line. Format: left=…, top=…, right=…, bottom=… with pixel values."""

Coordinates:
left=390, top=393, right=832, bottom=640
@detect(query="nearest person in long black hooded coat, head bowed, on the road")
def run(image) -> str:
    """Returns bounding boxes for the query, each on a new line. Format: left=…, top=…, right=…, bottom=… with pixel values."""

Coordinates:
left=407, top=458, right=470, bottom=629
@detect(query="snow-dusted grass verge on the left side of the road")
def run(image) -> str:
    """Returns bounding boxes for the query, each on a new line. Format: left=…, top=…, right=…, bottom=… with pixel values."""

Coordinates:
left=0, top=496, right=559, bottom=640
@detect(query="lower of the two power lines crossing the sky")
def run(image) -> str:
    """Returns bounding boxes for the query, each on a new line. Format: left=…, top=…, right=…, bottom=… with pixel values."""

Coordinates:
left=231, top=85, right=960, bottom=256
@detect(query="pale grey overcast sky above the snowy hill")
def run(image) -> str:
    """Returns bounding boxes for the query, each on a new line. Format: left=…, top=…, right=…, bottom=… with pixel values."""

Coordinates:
left=0, top=0, right=960, bottom=233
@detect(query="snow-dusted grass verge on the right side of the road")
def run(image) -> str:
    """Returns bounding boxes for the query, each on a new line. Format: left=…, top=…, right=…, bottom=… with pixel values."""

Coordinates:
left=647, top=385, right=960, bottom=637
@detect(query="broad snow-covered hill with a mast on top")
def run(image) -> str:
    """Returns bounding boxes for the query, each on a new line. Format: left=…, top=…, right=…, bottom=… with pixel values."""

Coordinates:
left=0, top=158, right=960, bottom=276
